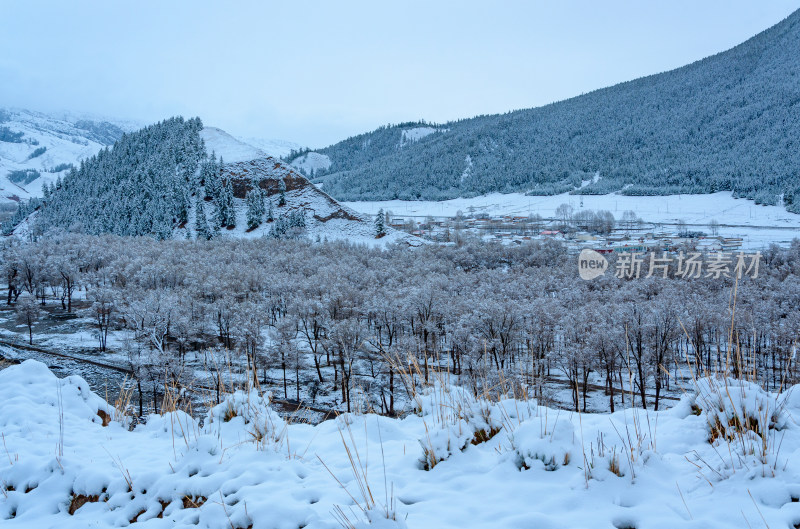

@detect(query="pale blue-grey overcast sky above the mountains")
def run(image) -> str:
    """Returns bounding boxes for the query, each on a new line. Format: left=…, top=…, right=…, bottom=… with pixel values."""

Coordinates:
left=0, top=0, right=800, bottom=147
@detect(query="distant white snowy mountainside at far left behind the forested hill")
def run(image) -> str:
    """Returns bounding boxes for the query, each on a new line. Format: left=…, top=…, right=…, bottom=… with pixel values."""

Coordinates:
left=0, top=109, right=139, bottom=203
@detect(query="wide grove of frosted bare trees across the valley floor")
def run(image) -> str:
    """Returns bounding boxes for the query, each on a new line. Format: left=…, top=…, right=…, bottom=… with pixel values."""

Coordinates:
left=2, top=234, right=800, bottom=414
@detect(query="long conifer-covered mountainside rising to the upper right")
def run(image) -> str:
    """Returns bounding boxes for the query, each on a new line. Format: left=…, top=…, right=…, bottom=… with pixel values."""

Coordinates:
left=298, top=11, right=800, bottom=212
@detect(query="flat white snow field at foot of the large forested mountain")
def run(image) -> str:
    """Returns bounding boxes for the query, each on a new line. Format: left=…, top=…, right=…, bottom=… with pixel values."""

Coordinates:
left=343, top=191, right=800, bottom=249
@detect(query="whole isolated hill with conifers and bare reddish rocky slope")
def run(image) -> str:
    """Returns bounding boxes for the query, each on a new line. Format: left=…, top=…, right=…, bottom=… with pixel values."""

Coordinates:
left=4, top=117, right=421, bottom=245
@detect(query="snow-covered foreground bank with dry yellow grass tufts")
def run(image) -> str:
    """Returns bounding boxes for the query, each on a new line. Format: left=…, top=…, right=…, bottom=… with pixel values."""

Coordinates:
left=0, top=361, right=800, bottom=529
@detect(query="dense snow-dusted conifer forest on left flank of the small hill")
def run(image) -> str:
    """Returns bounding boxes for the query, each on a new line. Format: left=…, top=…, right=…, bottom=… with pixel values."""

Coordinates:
left=12, top=118, right=206, bottom=238
